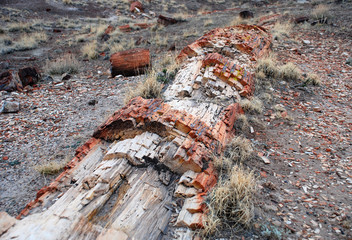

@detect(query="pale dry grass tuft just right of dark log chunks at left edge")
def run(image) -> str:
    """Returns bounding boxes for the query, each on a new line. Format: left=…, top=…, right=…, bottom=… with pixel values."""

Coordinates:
left=44, top=54, right=80, bottom=75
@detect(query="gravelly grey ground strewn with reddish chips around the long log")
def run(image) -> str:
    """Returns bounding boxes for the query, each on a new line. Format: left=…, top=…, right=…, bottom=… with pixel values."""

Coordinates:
left=0, top=0, right=352, bottom=239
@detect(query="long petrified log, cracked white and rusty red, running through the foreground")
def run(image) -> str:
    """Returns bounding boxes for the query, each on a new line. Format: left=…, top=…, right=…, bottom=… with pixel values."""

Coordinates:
left=0, top=25, right=271, bottom=239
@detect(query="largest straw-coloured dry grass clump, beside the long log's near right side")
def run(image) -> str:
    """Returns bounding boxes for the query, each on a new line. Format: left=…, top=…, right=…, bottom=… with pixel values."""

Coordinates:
left=201, top=137, right=256, bottom=237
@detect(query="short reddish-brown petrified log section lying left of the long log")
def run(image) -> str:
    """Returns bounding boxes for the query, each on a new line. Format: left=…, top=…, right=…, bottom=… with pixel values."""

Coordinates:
left=110, top=48, right=150, bottom=77
